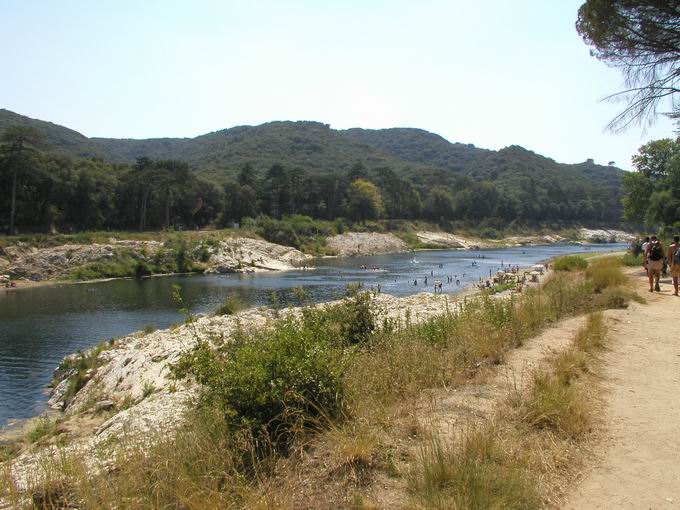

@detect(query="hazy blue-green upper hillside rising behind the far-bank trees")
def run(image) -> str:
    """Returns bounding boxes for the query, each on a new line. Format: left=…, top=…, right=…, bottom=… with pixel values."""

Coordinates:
left=0, top=109, right=622, bottom=187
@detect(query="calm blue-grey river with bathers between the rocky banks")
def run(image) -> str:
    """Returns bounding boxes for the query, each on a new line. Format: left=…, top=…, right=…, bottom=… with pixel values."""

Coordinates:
left=0, top=244, right=624, bottom=427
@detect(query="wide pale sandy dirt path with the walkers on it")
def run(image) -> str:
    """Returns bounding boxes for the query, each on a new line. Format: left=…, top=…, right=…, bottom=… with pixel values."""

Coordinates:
left=563, top=270, right=680, bottom=510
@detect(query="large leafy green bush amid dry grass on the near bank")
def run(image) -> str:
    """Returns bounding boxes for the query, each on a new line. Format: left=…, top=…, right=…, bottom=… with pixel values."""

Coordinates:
left=174, top=296, right=375, bottom=447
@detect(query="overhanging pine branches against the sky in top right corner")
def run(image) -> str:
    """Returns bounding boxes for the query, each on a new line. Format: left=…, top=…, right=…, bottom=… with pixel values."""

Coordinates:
left=576, top=0, right=680, bottom=130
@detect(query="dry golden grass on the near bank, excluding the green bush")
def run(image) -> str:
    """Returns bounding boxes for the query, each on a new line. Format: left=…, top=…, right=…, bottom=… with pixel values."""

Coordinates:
left=4, top=268, right=625, bottom=510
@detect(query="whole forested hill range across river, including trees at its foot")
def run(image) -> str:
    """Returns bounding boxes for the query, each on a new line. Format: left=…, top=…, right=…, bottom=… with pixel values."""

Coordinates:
left=0, top=110, right=623, bottom=233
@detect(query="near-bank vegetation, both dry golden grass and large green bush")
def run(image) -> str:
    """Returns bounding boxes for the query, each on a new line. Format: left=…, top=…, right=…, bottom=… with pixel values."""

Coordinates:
left=2, top=255, right=636, bottom=509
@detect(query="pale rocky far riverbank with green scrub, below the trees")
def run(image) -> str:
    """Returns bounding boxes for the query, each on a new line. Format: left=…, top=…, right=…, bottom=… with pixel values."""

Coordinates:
left=0, top=228, right=635, bottom=287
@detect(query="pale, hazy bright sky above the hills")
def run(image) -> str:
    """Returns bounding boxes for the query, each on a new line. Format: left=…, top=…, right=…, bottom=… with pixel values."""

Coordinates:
left=0, top=0, right=674, bottom=169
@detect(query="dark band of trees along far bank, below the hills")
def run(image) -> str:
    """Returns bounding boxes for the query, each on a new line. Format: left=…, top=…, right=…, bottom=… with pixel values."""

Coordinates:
left=0, top=127, right=619, bottom=232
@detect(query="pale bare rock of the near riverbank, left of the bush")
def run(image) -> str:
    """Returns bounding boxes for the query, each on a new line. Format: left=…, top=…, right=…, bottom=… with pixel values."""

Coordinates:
left=0, top=293, right=462, bottom=492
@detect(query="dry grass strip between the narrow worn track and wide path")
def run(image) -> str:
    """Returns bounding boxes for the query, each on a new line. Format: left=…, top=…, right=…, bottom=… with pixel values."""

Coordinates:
left=407, top=304, right=606, bottom=510
